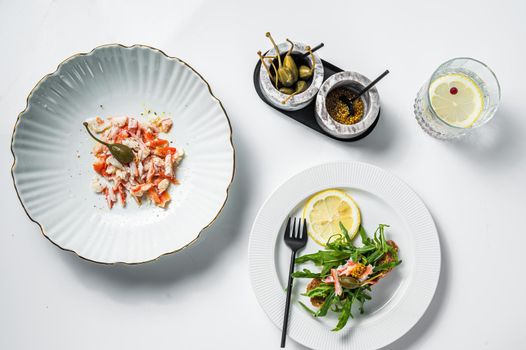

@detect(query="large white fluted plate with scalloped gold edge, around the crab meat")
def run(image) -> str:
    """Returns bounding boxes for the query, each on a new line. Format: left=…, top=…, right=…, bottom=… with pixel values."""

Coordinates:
left=11, top=45, right=234, bottom=264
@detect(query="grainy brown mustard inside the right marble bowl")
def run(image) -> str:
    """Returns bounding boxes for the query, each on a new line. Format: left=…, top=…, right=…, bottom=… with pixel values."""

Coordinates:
left=325, top=87, right=364, bottom=125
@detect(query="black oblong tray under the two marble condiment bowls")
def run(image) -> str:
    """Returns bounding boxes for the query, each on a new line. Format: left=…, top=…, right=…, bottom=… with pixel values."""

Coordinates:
left=254, top=60, right=380, bottom=142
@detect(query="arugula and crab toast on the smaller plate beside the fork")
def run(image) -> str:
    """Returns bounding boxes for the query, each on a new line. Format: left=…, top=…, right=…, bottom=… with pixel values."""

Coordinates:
left=292, top=221, right=402, bottom=331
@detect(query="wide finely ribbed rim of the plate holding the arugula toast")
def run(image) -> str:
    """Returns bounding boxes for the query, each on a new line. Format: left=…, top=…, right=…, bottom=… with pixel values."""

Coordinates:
left=248, top=162, right=441, bottom=350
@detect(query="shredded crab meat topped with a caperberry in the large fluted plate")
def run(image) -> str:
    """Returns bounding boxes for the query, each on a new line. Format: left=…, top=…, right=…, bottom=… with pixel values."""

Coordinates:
left=84, top=117, right=184, bottom=209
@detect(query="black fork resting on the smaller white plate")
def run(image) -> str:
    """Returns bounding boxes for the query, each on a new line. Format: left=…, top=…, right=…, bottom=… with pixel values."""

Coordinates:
left=281, top=218, right=307, bottom=348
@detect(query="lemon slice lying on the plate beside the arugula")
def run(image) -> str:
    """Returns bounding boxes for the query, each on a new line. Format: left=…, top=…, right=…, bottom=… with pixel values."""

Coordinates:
left=303, top=189, right=361, bottom=245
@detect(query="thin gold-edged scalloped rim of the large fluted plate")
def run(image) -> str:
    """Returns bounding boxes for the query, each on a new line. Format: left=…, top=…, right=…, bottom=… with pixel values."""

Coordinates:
left=10, top=43, right=236, bottom=265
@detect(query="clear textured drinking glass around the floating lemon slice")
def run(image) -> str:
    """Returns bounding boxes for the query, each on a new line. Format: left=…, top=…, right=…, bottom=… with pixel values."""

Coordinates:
left=414, top=57, right=500, bottom=139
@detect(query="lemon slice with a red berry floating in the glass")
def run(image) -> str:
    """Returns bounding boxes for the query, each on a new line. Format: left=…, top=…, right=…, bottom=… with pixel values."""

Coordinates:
left=429, top=74, right=484, bottom=128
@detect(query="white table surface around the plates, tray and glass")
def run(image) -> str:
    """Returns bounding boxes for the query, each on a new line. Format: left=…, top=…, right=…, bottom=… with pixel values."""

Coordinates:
left=0, top=0, right=526, bottom=350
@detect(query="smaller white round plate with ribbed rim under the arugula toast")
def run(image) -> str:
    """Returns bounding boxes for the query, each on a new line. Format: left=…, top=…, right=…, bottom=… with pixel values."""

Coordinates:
left=249, top=162, right=440, bottom=350
